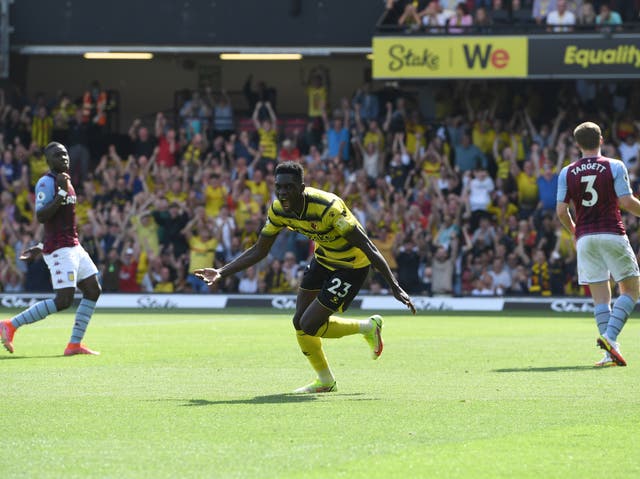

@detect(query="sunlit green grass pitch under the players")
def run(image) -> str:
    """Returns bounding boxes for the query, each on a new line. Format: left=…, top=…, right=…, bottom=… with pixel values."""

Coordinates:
left=0, top=311, right=640, bottom=479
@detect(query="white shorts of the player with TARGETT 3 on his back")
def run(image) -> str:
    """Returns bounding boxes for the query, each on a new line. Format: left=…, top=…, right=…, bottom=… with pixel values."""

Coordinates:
left=576, top=234, right=640, bottom=284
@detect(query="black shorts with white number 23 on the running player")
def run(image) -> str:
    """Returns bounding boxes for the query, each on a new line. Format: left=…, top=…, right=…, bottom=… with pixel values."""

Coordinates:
left=300, top=258, right=370, bottom=312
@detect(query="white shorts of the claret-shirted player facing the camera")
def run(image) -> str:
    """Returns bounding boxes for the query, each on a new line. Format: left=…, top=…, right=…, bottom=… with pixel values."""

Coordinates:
left=44, top=245, right=98, bottom=289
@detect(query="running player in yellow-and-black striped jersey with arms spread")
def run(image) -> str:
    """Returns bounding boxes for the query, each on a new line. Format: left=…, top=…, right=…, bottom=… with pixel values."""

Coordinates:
left=194, top=162, right=416, bottom=393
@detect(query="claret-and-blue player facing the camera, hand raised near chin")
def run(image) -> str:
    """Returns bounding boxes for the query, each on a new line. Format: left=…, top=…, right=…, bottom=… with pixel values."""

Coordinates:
left=0, top=142, right=101, bottom=356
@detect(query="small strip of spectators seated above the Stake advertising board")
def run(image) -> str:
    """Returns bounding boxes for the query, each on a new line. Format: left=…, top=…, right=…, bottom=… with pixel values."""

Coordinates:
left=379, top=0, right=640, bottom=34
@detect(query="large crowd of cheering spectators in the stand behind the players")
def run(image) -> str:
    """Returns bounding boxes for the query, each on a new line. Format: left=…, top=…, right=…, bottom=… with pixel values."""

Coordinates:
left=0, top=72, right=640, bottom=296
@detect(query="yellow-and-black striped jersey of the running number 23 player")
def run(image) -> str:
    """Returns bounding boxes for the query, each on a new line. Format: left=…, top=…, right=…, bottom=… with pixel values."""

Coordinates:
left=260, top=187, right=371, bottom=271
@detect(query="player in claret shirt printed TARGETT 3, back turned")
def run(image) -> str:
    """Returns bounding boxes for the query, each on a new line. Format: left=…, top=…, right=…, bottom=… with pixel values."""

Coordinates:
left=556, top=122, right=640, bottom=366
